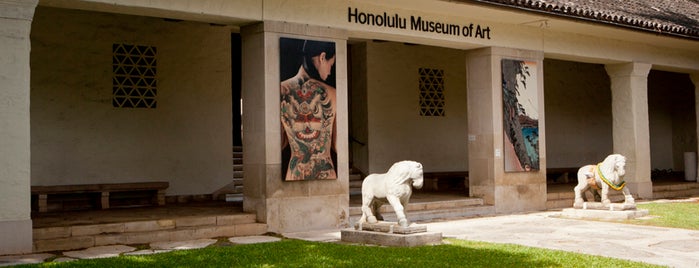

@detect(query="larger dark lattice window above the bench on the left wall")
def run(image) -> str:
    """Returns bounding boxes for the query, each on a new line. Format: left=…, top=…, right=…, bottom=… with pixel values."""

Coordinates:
left=112, top=44, right=157, bottom=108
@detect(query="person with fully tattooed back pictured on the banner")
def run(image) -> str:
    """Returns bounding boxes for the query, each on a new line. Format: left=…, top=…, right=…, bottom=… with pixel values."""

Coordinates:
left=280, top=38, right=337, bottom=181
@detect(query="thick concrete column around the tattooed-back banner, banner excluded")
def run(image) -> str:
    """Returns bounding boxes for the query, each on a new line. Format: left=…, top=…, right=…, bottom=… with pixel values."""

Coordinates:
left=241, top=21, right=349, bottom=233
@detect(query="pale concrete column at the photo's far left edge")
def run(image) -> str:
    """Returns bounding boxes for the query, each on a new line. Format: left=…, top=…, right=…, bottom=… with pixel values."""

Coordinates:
left=0, top=0, right=38, bottom=255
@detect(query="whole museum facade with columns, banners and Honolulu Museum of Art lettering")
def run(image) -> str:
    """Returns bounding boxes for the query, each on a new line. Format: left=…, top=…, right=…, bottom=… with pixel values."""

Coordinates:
left=0, top=0, right=699, bottom=254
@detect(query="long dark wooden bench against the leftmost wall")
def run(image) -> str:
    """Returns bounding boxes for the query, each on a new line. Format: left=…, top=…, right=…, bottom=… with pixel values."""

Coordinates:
left=31, top=182, right=170, bottom=212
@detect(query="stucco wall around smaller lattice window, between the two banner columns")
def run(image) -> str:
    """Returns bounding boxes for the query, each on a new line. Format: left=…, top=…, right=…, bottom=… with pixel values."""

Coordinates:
left=364, top=42, right=468, bottom=173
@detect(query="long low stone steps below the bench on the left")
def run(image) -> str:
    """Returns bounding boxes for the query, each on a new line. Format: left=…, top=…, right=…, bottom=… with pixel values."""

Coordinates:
left=33, top=214, right=267, bottom=252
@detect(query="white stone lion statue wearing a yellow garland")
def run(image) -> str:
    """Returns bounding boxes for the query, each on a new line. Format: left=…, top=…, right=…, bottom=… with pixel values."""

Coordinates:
left=573, top=154, right=635, bottom=208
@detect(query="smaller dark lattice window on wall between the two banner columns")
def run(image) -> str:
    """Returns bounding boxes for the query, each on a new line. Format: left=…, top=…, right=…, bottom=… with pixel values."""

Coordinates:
left=419, top=68, right=444, bottom=116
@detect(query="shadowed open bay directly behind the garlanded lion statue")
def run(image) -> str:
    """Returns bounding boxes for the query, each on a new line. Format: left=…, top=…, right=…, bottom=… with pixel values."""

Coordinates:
left=544, top=59, right=613, bottom=187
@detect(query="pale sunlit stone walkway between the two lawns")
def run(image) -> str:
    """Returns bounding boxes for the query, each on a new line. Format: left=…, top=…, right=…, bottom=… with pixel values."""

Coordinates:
left=427, top=211, right=699, bottom=267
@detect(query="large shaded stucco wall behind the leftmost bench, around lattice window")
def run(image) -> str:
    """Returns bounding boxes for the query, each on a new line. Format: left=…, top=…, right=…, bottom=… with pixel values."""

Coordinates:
left=31, top=7, right=232, bottom=195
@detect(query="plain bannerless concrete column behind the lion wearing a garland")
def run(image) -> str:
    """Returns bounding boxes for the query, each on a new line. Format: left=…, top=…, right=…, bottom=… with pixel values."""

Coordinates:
left=605, top=62, right=653, bottom=198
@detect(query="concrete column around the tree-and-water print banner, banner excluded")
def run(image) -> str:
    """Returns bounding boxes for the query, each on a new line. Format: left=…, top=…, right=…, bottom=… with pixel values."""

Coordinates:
left=467, top=48, right=546, bottom=213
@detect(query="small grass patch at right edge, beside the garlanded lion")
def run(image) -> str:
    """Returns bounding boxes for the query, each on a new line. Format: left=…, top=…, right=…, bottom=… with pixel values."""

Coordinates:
left=628, top=201, right=699, bottom=230
